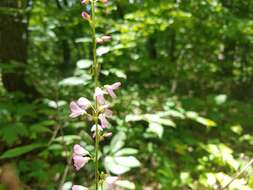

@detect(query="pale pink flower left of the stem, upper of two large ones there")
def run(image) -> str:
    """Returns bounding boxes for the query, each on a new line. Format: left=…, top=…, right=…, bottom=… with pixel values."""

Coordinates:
left=69, top=97, right=91, bottom=118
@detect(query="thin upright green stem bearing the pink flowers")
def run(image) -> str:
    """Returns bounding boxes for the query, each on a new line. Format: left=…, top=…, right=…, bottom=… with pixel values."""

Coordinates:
left=91, top=0, right=99, bottom=190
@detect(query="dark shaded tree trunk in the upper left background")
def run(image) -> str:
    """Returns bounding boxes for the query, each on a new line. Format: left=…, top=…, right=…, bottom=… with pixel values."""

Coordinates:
left=0, top=0, right=39, bottom=96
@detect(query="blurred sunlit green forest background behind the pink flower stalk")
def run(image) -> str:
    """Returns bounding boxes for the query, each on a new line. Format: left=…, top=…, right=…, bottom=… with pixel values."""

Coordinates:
left=0, top=0, right=253, bottom=190
